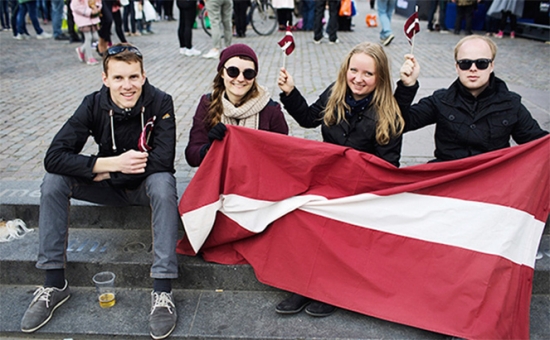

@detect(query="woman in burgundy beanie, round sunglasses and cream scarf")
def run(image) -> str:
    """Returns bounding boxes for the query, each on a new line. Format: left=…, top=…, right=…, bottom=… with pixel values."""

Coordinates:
left=185, top=44, right=288, bottom=166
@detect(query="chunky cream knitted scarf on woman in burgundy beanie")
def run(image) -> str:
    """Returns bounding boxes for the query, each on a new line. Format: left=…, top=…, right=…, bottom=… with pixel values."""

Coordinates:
left=221, top=86, right=271, bottom=130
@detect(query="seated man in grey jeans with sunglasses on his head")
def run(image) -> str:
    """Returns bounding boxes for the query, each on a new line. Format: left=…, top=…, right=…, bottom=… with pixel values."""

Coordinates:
left=21, top=44, right=179, bottom=339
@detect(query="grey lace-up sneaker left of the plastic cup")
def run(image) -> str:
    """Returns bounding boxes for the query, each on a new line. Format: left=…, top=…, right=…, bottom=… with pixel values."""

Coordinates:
left=21, top=281, right=71, bottom=333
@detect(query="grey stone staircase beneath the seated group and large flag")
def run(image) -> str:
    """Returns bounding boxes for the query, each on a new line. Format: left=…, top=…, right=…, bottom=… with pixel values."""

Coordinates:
left=0, top=198, right=550, bottom=339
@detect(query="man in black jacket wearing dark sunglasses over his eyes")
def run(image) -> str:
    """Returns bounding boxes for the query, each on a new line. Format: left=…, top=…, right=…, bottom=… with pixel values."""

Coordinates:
left=402, top=35, right=548, bottom=161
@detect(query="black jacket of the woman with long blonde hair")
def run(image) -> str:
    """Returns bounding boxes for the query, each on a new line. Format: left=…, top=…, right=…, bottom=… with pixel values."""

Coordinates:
left=280, top=81, right=418, bottom=166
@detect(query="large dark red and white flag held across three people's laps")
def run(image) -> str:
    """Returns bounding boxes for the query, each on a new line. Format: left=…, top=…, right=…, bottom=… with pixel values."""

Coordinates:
left=178, top=126, right=550, bottom=339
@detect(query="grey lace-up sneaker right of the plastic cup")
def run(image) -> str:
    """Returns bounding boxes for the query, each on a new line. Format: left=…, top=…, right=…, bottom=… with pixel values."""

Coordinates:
left=149, top=291, right=178, bottom=340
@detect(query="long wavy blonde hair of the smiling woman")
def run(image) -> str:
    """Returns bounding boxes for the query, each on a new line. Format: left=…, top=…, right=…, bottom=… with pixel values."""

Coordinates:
left=323, top=42, right=405, bottom=145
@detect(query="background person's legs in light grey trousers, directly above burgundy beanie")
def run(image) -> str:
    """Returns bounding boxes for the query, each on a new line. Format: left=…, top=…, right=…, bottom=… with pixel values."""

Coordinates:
left=203, top=0, right=233, bottom=59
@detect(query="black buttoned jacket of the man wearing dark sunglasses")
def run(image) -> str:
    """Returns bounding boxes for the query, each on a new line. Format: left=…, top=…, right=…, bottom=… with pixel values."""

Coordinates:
left=402, top=74, right=548, bottom=161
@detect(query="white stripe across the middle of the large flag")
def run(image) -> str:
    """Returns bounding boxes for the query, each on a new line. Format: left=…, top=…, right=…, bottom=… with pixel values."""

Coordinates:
left=182, top=193, right=544, bottom=268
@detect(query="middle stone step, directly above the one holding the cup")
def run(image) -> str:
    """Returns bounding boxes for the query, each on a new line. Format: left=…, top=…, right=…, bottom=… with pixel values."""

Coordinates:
left=0, top=224, right=550, bottom=294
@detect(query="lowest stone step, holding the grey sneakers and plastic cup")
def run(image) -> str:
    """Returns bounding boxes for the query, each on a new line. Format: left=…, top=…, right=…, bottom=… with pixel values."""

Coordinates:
left=0, top=285, right=550, bottom=340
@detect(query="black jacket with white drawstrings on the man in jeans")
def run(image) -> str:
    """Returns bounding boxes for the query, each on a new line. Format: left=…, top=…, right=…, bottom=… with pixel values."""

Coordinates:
left=44, top=81, right=176, bottom=189
